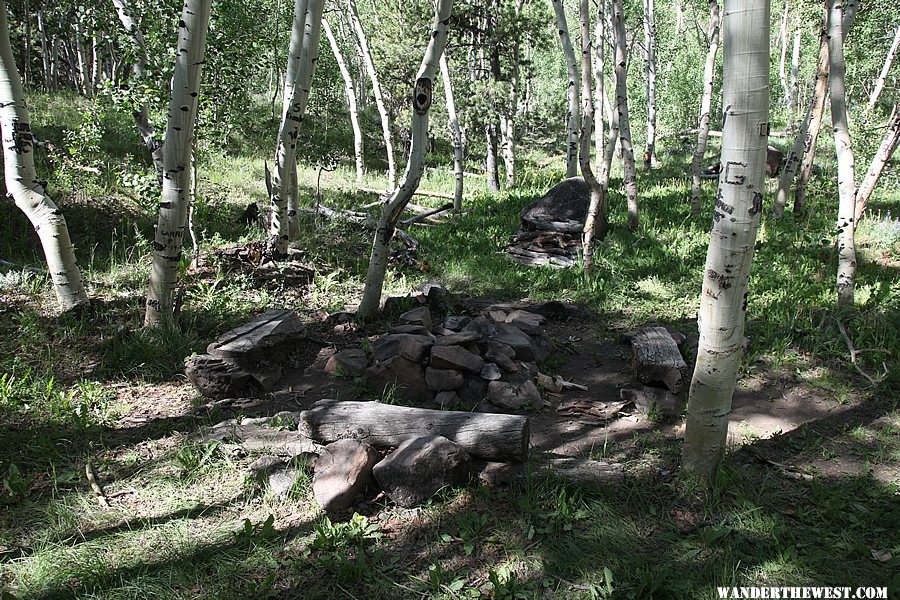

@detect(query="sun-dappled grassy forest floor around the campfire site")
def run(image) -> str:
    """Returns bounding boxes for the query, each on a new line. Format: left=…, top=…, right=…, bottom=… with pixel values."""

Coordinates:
left=0, top=92, right=900, bottom=600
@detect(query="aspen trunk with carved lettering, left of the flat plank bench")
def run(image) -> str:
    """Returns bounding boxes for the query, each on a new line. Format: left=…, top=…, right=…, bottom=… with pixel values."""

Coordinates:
left=144, top=0, right=212, bottom=327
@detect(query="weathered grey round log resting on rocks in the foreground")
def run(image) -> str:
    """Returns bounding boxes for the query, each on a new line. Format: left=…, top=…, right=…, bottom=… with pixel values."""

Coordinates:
left=299, top=400, right=530, bottom=461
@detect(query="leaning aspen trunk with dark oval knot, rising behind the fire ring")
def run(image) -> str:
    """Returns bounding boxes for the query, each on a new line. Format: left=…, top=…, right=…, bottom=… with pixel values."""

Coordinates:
left=357, top=0, right=453, bottom=320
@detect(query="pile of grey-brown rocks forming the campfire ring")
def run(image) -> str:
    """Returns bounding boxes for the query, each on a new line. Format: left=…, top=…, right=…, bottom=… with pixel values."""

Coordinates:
left=325, top=306, right=552, bottom=411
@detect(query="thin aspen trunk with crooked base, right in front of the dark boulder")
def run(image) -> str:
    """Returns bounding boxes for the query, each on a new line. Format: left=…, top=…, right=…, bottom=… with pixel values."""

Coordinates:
left=578, top=0, right=608, bottom=273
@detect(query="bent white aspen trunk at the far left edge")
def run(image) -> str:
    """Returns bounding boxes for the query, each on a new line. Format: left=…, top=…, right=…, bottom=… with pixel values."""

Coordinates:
left=0, top=0, right=88, bottom=310
